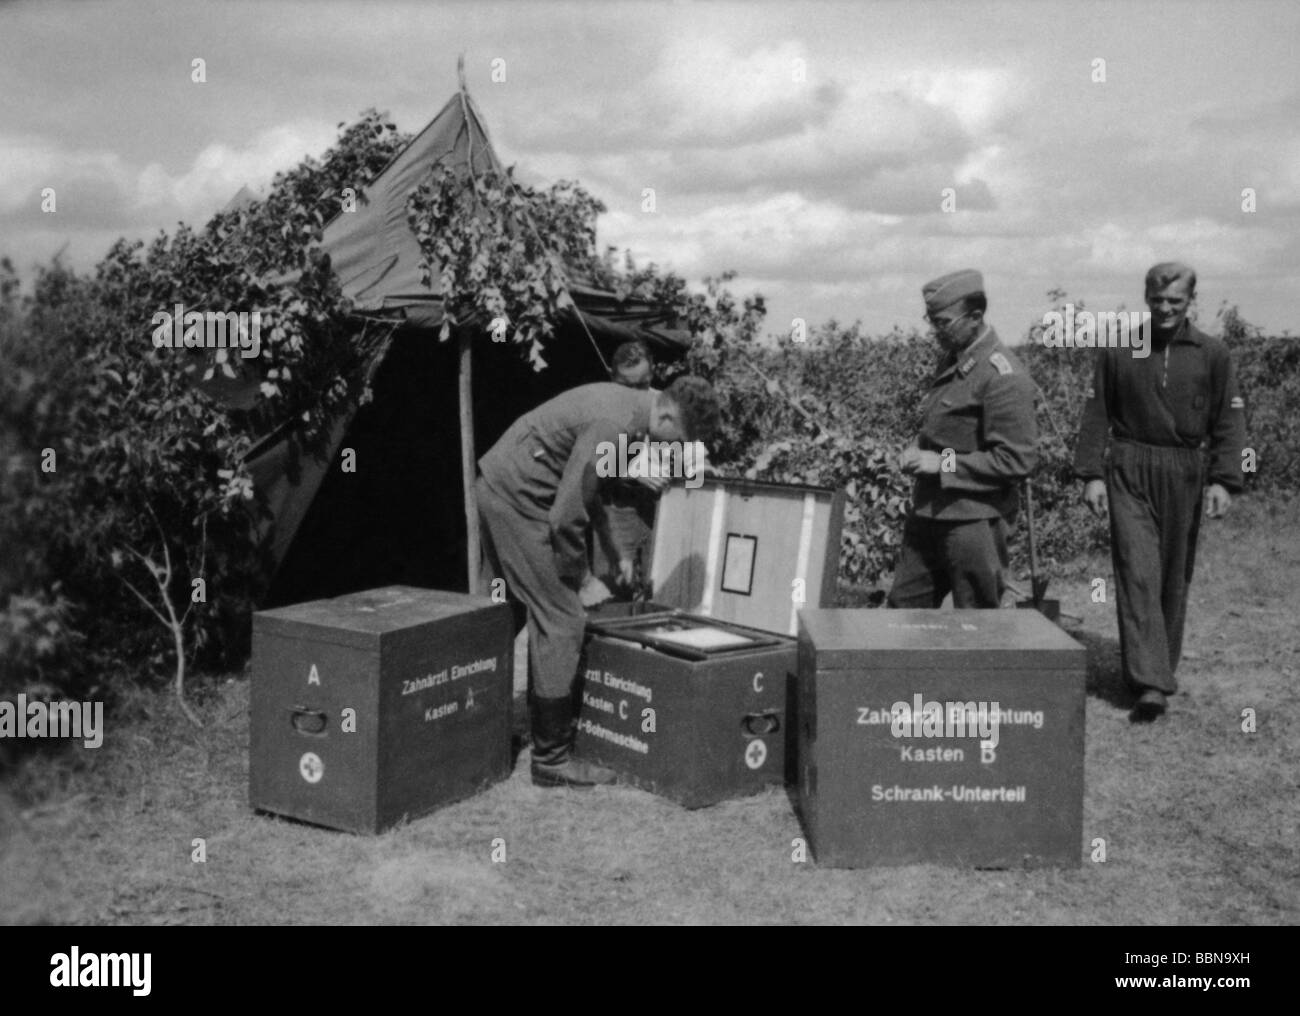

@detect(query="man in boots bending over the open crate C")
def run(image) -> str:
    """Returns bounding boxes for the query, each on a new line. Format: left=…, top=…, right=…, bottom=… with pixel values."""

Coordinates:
left=475, top=377, right=719, bottom=786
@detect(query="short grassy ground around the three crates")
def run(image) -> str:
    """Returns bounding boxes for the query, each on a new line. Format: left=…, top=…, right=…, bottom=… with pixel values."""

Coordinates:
left=0, top=502, right=1300, bottom=925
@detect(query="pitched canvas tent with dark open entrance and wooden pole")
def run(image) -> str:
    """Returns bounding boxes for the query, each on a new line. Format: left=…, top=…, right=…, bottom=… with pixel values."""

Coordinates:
left=235, top=87, right=688, bottom=607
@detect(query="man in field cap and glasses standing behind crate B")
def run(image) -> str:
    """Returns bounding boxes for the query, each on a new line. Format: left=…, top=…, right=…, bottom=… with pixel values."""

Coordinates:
left=888, top=269, right=1037, bottom=608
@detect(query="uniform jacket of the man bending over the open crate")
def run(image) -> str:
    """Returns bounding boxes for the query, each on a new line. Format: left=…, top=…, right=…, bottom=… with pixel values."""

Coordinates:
left=478, top=382, right=654, bottom=581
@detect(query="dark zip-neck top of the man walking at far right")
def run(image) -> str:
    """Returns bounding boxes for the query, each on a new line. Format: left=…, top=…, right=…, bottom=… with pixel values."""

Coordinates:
left=1074, top=321, right=1245, bottom=491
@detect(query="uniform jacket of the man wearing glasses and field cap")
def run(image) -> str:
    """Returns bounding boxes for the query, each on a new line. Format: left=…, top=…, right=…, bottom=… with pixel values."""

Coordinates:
left=911, top=325, right=1039, bottom=521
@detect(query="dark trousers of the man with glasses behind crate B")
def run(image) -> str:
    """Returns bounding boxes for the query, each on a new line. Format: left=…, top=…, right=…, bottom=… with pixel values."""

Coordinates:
left=887, top=516, right=1008, bottom=609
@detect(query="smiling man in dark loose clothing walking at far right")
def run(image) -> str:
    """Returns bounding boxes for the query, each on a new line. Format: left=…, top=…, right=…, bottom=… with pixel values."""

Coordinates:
left=1074, top=261, right=1245, bottom=721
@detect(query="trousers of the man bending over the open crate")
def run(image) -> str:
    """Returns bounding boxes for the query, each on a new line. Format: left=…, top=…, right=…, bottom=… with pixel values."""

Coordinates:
left=475, top=477, right=586, bottom=699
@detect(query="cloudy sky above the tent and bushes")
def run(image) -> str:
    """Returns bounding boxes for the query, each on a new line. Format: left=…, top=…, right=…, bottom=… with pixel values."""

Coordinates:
left=0, top=0, right=1300, bottom=342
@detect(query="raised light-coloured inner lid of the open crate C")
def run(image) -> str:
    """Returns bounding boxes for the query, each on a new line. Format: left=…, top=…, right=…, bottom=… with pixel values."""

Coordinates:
left=650, top=477, right=844, bottom=635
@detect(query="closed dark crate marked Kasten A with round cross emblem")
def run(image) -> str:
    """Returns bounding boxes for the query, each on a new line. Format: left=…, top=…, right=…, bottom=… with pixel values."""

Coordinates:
left=248, top=586, right=512, bottom=833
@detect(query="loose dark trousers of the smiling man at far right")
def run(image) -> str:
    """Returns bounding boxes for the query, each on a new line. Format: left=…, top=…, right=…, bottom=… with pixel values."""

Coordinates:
left=1106, top=440, right=1205, bottom=694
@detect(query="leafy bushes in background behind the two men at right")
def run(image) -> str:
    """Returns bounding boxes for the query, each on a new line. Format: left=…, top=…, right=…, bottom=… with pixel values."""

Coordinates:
left=688, top=298, right=1300, bottom=592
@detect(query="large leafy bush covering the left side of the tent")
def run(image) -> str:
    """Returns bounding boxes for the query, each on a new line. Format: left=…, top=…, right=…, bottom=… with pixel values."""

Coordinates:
left=0, top=110, right=404, bottom=707
